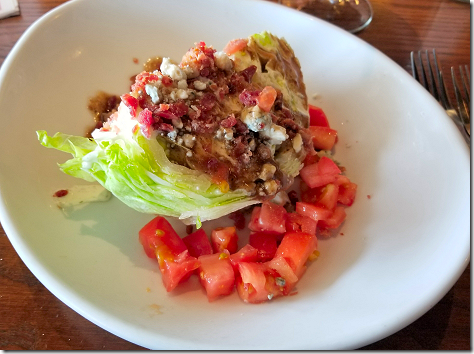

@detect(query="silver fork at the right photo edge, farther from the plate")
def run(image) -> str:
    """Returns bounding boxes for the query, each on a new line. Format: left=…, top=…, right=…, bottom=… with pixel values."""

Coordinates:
left=451, top=65, right=471, bottom=136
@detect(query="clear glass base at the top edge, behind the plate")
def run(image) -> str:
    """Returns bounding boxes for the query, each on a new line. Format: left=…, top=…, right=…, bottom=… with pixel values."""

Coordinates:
left=278, top=0, right=373, bottom=33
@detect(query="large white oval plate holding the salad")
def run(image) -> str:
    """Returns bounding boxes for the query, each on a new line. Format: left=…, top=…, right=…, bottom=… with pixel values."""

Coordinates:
left=0, top=0, right=470, bottom=349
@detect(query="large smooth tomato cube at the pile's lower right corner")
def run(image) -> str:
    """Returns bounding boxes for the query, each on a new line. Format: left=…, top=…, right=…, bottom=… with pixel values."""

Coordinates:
left=275, top=232, right=318, bottom=279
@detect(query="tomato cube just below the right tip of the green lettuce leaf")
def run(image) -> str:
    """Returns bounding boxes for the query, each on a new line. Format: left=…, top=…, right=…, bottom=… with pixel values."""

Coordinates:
left=249, top=202, right=286, bottom=234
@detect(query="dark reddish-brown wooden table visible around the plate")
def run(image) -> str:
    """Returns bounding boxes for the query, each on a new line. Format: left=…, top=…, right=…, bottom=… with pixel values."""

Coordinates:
left=0, top=0, right=471, bottom=350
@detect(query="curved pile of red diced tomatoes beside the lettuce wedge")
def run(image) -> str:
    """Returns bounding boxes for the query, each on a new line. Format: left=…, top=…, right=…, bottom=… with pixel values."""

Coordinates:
left=139, top=106, right=357, bottom=303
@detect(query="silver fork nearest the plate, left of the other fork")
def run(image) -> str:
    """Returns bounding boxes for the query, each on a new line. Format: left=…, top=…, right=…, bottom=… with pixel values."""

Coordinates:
left=410, top=49, right=470, bottom=142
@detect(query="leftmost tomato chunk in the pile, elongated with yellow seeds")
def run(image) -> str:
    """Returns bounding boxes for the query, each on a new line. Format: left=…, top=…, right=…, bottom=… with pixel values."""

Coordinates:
left=138, top=216, right=199, bottom=291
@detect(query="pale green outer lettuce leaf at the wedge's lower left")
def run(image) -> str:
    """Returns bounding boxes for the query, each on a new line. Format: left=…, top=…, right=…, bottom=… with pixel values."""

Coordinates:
left=37, top=130, right=259, bottom=224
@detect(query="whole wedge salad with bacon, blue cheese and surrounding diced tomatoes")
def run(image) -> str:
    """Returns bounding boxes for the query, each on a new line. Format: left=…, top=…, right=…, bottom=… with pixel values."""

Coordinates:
left=37, top=32, right=357, bottom=303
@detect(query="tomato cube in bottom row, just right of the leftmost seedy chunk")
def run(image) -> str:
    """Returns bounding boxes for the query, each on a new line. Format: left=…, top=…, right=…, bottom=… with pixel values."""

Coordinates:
left=199, top=252, right=235, bottom=301
